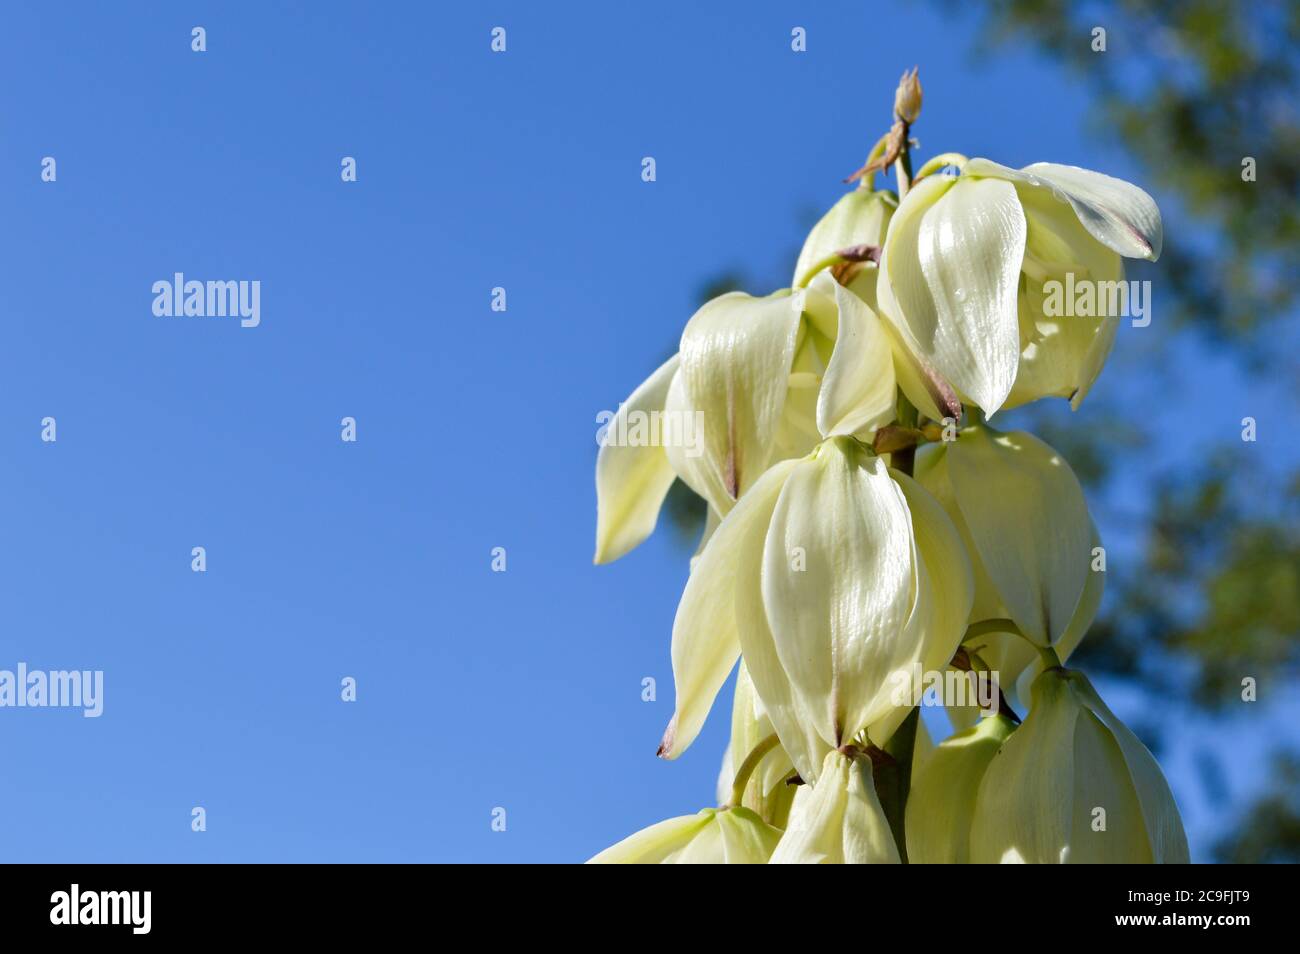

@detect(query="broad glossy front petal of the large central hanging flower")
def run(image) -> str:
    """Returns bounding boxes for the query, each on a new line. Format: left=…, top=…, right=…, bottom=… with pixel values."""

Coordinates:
left=746, top=438, right=918, bottom=772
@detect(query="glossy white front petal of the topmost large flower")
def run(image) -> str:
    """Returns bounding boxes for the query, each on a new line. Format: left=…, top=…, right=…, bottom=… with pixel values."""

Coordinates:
left=878, top=175, right=1026, bottom=415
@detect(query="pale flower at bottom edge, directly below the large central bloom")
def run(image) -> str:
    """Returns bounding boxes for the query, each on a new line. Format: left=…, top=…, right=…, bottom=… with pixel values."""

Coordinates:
left=771, top=751, right=900, bottom=864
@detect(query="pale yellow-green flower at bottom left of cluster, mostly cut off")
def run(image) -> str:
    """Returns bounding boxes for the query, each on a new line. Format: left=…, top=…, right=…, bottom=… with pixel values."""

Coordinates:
left=588, top=808, right=781, bottom=864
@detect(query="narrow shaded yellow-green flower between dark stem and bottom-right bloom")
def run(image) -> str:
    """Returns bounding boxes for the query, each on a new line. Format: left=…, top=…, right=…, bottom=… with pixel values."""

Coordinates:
left=906, top=715, right=1015, bottom=864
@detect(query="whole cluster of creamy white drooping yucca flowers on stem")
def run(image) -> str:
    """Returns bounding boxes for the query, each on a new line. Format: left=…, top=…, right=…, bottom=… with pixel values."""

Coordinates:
left=592, top=70, right=1188, bottom=863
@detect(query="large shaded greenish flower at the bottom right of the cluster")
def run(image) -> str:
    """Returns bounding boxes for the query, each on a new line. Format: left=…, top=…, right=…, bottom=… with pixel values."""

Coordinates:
left=971, top=667, right=1188, bottom=864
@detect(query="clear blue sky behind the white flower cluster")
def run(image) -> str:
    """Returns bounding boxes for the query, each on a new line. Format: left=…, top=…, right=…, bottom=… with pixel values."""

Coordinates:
left=0, top=3, right=1289, bottom=862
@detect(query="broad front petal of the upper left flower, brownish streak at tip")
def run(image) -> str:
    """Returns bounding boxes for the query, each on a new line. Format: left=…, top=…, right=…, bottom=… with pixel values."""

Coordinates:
left=668, top=291, right=803, bottom=515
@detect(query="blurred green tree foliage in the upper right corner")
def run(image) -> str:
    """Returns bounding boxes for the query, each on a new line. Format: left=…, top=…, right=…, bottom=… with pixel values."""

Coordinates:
left=972, top=0, right=1300, bottom=348
